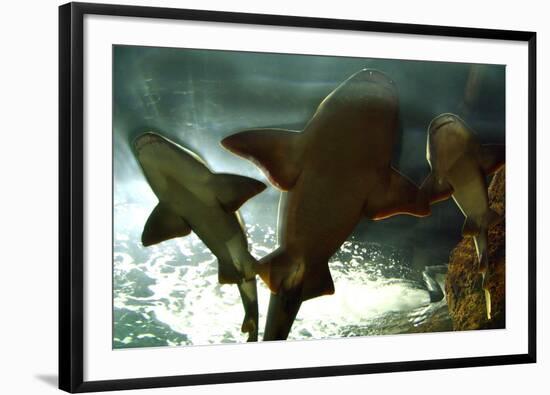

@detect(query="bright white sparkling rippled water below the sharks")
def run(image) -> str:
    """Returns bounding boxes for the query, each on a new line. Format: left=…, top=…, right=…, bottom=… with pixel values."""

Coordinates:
left=113, top=201, right=450, bottom=348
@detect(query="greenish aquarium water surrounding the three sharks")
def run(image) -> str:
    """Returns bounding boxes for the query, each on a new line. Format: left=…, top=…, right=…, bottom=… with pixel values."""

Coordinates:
left=113, top=46, right=505, bottom=348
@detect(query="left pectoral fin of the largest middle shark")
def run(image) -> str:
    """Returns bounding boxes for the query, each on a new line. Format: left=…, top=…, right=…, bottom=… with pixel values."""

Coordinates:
left=221, top=129, right=301, bottom=191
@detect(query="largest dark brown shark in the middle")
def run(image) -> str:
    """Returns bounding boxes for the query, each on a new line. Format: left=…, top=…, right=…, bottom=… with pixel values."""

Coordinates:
left=222, top=69, right=429, bottom=340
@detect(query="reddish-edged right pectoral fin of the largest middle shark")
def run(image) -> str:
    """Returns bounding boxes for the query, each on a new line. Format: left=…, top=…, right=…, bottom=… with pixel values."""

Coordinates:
left=367, top=168, right=431, bottom=220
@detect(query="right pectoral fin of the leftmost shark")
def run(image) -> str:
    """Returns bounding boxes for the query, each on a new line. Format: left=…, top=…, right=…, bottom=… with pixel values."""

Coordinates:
left=212, top=173, right=266, bottom=212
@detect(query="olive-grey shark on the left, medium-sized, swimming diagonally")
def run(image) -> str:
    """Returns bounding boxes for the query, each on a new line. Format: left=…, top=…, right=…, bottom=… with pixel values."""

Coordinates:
left=134, top=132, right=265, bottom=341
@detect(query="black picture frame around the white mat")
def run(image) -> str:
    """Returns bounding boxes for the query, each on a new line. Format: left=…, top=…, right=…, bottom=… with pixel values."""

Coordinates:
left=59, top=3, right=536, bottom=393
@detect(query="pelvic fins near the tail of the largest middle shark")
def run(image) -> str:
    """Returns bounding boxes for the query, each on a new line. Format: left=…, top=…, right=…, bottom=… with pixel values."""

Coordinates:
left=257, top=249, right=334, bottom=301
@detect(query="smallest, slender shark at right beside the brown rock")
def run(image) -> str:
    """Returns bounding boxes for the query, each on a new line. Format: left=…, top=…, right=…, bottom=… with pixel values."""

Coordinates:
left=421, top=113, right=505, bottom=319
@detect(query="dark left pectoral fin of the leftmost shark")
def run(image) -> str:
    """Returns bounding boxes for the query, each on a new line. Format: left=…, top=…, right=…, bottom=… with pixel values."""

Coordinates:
left=141, top=203, right=191, bottom=247
